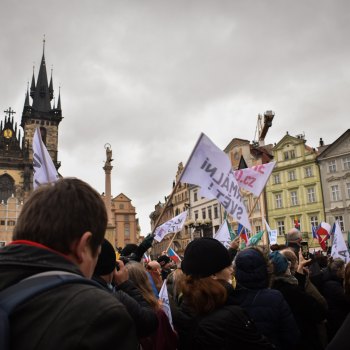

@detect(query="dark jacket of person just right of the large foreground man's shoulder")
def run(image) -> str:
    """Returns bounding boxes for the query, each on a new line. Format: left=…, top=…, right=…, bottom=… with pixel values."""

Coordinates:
left=93, top=276, right=158, bottom=338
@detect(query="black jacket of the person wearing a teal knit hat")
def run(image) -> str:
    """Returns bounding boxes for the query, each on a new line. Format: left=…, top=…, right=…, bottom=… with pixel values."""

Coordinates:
left=272, top=276, right=326, bottom=350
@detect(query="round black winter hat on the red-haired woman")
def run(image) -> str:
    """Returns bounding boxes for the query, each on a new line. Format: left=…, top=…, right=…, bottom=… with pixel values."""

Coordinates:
left=181, top=237, right=231, bottom=277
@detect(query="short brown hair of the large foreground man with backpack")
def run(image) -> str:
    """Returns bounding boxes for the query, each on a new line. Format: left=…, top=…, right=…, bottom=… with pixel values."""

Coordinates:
left=13, top=178, right=107, bottom=264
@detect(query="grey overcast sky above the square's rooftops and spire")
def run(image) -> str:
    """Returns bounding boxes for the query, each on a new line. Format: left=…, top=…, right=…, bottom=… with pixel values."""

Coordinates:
left=0, top=0, right=350, bottom=234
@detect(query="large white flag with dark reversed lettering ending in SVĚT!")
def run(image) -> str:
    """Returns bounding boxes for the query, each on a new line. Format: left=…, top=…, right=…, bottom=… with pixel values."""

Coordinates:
left=180, top=133, right=251, bottom=230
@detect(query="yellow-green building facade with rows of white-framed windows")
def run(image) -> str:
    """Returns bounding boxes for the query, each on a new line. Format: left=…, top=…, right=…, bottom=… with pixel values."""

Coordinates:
left=266, top=133, right=325, bottom=245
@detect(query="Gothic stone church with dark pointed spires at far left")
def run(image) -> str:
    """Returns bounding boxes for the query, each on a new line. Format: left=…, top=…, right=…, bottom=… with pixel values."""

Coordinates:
left=0, top=40, right=62, bottom=205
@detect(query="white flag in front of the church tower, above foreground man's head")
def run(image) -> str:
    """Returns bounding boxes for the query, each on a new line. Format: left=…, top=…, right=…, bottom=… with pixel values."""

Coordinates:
left=33, top=128, right=59, bottom=189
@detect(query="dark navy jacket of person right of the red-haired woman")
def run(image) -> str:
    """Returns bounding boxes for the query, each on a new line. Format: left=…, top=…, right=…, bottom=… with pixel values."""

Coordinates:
left=233, top=285, right=300, bottom=349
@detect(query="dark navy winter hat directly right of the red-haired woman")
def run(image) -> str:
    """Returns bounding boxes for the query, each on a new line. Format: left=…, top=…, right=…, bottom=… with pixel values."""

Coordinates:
left=235, top=248, right=268, bottom=289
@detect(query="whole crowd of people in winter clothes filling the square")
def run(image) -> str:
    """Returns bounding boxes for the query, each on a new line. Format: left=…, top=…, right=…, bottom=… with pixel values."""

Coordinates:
left=0, top=178, right=350, bottom=350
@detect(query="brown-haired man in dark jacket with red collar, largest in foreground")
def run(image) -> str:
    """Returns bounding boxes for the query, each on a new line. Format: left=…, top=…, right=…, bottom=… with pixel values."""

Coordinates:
left=0, top=178, right=138, bottom=350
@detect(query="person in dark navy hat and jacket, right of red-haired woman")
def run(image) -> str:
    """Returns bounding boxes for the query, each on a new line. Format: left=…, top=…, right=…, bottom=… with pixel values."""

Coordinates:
left=233, top=247, right=300, bottom=349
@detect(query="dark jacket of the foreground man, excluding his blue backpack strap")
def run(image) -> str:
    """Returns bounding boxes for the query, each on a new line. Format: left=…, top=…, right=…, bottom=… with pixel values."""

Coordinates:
left=0, top=244, right=137, bottom=350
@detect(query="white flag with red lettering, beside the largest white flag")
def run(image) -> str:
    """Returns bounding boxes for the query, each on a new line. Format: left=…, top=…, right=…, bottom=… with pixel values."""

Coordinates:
left=235, top=162, right=276, bottom=197
